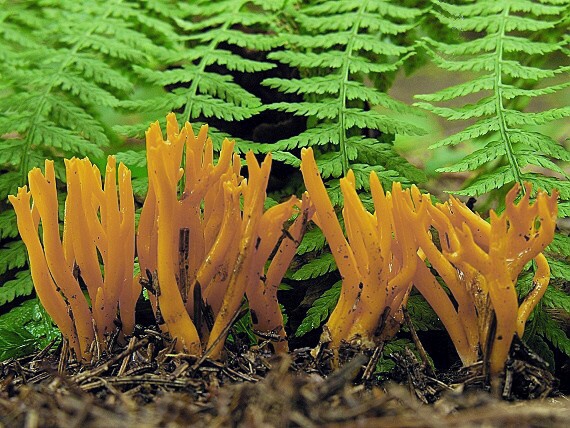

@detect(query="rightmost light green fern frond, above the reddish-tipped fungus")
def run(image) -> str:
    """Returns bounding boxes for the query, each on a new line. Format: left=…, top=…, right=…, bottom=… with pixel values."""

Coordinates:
left=417, top=0, right=570, bottom=200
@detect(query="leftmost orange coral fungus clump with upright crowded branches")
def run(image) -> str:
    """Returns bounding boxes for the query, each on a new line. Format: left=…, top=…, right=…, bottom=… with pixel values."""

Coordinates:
left=10, top=157, right=140, bottom=360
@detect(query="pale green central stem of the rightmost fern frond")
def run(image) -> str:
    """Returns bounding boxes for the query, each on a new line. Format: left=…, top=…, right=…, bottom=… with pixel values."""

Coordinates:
left=495, top=6, right=524, bottom=193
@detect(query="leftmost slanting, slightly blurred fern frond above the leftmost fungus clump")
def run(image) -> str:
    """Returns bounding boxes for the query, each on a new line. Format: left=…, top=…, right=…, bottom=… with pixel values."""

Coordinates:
left=0, top=1, right=169, bottom=184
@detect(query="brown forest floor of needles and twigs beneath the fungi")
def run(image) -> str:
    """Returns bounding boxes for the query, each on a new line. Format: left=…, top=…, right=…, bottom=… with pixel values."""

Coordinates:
left=0, top=330, right=570, bottom=428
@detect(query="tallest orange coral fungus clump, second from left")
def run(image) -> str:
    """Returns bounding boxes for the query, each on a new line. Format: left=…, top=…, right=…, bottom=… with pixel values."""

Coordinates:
left=138, top=114, right=309, bottom=358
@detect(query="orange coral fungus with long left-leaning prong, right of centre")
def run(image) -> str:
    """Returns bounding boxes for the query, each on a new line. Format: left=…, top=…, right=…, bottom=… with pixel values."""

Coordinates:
left=301, top=149, right=417, bottom=348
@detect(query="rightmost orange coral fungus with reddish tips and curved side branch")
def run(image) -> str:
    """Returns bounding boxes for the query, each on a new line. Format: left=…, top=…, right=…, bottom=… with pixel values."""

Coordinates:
left=438, top=184, right=558, bottom=374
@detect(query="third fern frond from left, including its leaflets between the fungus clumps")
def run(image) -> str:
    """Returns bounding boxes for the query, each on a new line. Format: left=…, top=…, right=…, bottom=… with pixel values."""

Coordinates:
left=262, top=1, right=425, bottom=300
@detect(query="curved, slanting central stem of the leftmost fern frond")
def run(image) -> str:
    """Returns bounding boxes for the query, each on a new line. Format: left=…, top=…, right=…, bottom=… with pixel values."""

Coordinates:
left=20, top=0, right=123, bottom=183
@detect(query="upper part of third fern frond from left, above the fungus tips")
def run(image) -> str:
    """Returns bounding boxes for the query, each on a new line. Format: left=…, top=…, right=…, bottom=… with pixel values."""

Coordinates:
left=263, top=1, right=423, bottom=179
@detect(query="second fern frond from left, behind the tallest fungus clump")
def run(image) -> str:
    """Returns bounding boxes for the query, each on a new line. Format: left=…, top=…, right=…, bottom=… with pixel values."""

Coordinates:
left=122, top=0, right=282, bottom=151
